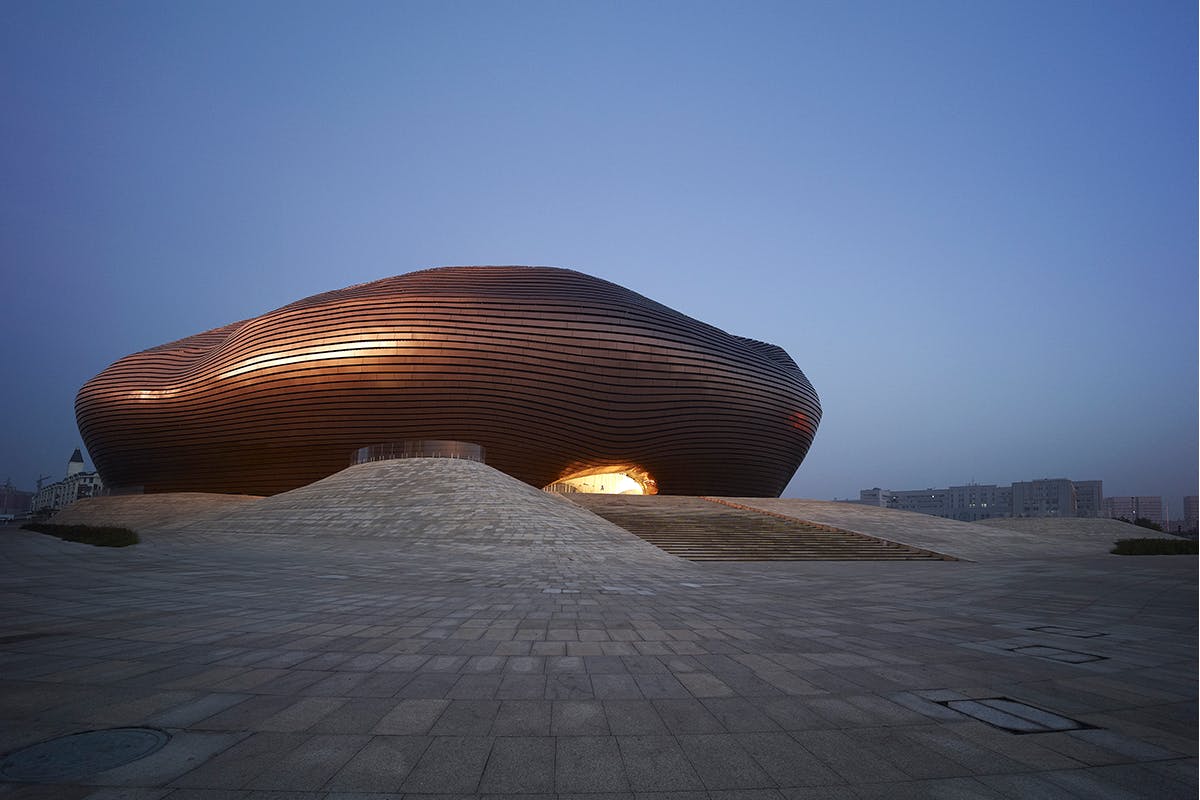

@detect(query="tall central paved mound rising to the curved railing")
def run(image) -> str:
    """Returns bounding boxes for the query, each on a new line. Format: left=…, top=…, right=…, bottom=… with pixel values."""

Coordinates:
left=164, top=458, right=674, bottom=561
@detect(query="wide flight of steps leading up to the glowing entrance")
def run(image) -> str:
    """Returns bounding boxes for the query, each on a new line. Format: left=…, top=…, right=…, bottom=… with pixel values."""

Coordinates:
left=565, top=493, right=954, bottom=561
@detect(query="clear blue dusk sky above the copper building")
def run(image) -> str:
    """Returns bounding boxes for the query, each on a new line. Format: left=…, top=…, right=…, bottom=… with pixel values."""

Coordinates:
left=0, top=0, right=1198, bottom=516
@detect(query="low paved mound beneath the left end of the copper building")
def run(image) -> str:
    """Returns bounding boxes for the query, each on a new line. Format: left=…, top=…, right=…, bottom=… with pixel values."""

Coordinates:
left=50, top=492, right=259, bottom=531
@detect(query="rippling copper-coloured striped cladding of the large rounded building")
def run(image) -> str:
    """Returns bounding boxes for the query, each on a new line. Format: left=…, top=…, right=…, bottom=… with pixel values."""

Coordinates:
left=76, top=266, right=821, bottom=497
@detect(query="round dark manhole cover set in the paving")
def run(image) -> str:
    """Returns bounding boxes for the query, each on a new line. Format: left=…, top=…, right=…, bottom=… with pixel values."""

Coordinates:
left=0, top=728, right=170, bottom=781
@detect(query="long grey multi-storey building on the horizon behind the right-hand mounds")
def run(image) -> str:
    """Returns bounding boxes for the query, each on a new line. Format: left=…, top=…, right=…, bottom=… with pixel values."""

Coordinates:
left=858, top=477, right=1104, bottom=522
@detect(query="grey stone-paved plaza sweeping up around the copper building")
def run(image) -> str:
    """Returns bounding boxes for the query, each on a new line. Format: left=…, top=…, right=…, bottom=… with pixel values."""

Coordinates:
left=0, top=465, right=1196, bottom=800
